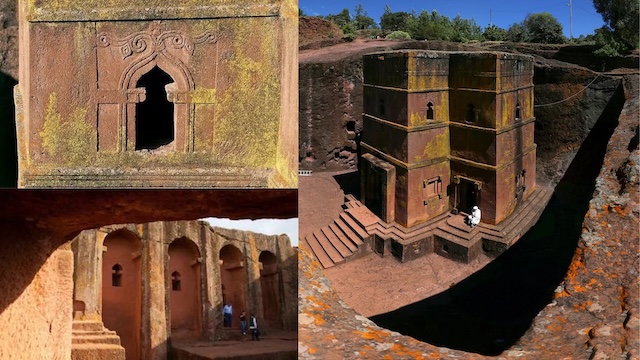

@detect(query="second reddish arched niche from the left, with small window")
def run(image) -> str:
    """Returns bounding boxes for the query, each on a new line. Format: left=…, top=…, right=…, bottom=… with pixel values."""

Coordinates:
left=168, top=238, right=202, bottom=338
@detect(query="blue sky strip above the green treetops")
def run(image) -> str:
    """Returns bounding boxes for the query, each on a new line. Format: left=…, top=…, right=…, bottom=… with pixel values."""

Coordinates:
left=299, top=0, right=604, bottom=38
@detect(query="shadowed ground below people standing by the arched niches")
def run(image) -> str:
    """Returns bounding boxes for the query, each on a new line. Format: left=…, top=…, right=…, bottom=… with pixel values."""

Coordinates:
left=174, top=332, right=298, bottom=359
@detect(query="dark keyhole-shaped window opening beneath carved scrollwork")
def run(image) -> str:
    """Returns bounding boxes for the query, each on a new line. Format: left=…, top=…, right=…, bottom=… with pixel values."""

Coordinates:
left=136, top=66, right=175, bottom=150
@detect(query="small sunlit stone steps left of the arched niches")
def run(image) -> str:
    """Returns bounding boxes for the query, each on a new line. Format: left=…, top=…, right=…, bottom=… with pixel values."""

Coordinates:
left=71, top=320, right=125, bottom=360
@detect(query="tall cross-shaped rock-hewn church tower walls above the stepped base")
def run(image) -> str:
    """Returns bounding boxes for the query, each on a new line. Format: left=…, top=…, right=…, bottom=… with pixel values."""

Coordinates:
left=360, top=50, right=536, bottom=227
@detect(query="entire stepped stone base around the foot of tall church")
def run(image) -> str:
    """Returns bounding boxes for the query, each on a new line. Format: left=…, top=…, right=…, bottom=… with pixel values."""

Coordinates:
left=305, top=186, right=553, bottom=268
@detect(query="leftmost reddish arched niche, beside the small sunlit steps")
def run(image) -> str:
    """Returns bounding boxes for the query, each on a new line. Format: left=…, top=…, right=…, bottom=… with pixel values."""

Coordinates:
left=102, top=229, right=142, bottom=360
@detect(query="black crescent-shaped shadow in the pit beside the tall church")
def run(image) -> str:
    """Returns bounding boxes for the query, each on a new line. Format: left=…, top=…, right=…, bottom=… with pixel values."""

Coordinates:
left=370, top=81, right=625, bottom=355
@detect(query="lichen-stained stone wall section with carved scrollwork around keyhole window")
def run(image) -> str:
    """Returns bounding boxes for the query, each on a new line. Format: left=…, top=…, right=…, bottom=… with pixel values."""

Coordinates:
left=15, top=0, right=298, bottom=187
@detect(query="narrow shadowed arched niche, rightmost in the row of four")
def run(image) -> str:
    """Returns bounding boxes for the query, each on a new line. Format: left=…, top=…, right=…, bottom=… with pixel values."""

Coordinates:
left=259, top=251, right=281, bottom=328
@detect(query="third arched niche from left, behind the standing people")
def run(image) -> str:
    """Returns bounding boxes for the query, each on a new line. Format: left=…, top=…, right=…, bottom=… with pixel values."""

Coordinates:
left=220, top=245, right=246, bottom=329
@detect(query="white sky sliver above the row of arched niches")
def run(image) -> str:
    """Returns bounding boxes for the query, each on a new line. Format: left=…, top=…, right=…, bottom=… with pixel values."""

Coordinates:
left=203, top=218, right=298, bottom=246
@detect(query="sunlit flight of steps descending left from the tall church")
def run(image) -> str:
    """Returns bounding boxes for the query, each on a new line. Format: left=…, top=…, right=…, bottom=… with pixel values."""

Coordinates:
left=305, top=195, right=379, bottom=268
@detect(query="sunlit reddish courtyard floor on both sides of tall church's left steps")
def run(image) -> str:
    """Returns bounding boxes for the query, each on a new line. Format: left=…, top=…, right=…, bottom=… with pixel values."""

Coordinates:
left=298, top=172, right=491, bottom=317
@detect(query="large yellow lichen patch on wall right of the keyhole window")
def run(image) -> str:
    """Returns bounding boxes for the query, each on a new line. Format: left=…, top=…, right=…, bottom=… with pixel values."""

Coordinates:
left=213, top=20, right=280, bottom=167
